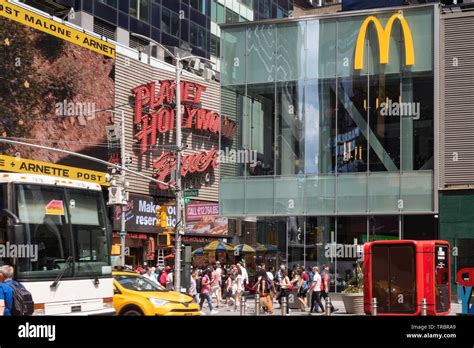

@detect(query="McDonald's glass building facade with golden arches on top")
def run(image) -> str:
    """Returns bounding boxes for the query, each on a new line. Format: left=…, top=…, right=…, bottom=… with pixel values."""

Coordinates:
left=220, top=6, right=437, bottom=291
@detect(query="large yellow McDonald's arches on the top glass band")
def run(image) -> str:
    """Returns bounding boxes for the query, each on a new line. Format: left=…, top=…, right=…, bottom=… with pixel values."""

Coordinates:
left=354, top=13, right=415, bottom=70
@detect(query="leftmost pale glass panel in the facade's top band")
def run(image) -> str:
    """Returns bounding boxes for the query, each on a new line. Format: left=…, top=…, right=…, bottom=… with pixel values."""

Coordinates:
left=221, top=28, right=247, bottom=85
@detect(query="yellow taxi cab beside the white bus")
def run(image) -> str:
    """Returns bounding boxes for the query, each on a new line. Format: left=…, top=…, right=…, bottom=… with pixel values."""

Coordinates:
left=112, top=271, right=200, bottom=316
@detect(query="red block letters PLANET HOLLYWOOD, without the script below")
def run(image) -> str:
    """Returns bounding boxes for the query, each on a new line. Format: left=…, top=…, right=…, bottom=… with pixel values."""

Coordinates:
left=131, top=80, right=236, bottom=153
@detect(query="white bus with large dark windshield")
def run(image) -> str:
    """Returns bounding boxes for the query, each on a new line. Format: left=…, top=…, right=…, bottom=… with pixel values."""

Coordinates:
left=0, top=172, right=115, bottom=315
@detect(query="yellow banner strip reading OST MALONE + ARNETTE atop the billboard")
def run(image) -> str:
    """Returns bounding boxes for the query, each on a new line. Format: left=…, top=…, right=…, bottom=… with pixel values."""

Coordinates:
left=0, top=0, right=115, bottom=58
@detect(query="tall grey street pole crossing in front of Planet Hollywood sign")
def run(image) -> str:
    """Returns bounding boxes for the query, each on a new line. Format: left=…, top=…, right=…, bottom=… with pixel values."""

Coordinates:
left=174, top=57, right=184, bottom=292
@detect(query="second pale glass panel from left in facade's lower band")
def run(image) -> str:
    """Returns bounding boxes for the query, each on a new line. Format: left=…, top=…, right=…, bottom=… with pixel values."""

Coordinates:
left=245, top=178, right=274, bottom=215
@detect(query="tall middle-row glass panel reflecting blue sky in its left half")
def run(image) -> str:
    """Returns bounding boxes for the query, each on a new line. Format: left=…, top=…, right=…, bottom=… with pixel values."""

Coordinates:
left=304, top=80, right=336, bottom=174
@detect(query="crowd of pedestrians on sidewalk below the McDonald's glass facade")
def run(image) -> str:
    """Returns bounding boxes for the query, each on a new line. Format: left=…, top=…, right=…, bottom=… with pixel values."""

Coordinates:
left=135, top=261, right=337, bottom=315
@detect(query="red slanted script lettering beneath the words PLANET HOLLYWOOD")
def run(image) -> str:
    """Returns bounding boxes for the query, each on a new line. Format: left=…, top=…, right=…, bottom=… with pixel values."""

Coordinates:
left=153, top=147, right=218, bottom=190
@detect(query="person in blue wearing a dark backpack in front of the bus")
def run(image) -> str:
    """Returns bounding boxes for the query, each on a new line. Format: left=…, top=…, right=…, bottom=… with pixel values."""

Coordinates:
left=0, top=265, right=35, bottom=316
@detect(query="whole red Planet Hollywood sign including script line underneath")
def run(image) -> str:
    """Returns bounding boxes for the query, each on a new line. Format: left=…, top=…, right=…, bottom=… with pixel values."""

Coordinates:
left=131, top=80, right=236, bottom=190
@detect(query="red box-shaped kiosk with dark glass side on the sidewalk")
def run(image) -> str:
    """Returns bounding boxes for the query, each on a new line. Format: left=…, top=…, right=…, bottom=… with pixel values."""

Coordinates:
left=364, top=240, right=451, bottom=316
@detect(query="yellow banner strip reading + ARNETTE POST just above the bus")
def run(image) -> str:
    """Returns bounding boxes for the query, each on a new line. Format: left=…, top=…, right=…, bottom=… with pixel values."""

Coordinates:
left=0, top=155, right=109, bottom=186
